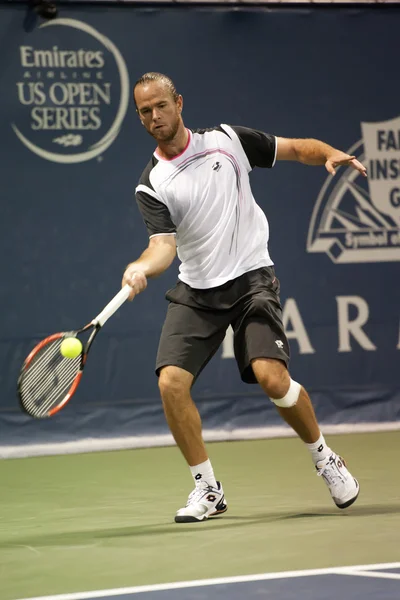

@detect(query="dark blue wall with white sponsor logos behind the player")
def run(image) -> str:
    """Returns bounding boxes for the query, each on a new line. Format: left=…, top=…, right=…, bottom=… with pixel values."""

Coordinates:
left=0, top=6, right=400, bottom=443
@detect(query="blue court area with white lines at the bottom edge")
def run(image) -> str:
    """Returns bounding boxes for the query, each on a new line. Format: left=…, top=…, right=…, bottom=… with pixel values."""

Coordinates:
left=20, top=563, right=400, bottom=600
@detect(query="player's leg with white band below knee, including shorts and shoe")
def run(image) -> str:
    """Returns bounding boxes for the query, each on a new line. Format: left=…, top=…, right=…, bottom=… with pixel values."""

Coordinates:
left=232, top=269, right=359, bottom=508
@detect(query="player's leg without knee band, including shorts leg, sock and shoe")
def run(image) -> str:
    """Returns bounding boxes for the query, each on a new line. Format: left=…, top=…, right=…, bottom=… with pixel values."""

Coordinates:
left=156, top=303, right=227, bottom=522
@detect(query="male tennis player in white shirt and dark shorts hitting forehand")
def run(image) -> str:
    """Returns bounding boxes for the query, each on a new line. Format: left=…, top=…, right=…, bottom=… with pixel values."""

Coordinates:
left=122, top=73, right=366, bottom=523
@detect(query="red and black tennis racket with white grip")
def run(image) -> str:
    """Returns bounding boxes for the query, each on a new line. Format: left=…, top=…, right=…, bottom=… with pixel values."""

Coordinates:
left=17, top=285, right=132, bottom=419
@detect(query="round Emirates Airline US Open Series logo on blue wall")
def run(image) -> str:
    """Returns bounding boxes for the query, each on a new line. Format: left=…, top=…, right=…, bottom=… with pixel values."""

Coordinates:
left=12, top=19, right=129, bottom=164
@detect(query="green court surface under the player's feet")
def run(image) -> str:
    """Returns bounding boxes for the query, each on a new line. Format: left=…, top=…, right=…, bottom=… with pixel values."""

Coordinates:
left=0, top=432, right=400, bottom=600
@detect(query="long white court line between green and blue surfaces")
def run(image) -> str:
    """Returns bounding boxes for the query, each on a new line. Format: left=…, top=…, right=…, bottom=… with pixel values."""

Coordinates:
left=12, top=562, right=400, bottom=600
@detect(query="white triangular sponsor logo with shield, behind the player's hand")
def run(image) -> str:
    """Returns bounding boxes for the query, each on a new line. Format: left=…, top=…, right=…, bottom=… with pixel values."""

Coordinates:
left=307, top=117, right=400, bottom=264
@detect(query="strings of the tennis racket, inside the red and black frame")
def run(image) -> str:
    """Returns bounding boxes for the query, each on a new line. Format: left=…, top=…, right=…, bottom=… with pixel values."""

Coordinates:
left=20, top=338, right=81, bottom=417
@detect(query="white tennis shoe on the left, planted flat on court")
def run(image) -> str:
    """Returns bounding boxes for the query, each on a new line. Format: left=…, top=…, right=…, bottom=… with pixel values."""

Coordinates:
left=175, top=481, right=228, bottom=523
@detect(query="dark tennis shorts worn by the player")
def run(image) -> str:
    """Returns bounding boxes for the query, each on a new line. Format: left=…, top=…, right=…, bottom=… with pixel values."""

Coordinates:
left=156, top=267, right=290, bottom=383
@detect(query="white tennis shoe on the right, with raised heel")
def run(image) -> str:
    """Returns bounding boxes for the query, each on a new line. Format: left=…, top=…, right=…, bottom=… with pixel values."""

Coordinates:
left=315, top=452, right=360, bottom=508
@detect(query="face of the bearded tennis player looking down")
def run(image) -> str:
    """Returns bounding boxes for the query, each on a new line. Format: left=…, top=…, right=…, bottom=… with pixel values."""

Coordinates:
left=135, top=81, right=182, bottom=142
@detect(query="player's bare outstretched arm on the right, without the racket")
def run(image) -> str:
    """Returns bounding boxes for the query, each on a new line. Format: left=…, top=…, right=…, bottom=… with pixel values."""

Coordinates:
left=276, top=137, right=367, bottom=177
